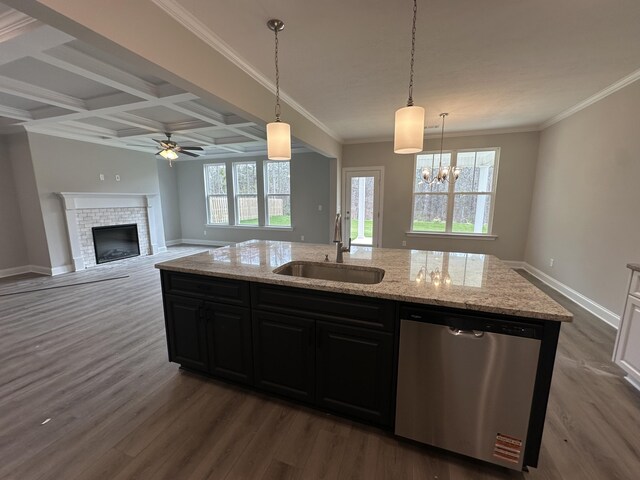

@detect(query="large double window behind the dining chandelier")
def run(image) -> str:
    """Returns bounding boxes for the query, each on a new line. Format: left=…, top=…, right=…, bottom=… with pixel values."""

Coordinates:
left=411, top=148, right=499, bottom=234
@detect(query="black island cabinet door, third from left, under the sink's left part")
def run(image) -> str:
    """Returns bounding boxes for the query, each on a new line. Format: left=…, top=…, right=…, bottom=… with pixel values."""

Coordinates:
left=253, top=311, right=315, bottom=402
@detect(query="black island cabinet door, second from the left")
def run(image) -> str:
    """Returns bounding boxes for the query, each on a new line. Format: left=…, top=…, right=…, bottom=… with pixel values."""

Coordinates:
left=206, top=303, right=253, bottom=384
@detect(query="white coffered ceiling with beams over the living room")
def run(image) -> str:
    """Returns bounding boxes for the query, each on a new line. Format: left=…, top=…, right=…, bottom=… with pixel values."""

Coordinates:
left=0, top=4, right=308, bottom=158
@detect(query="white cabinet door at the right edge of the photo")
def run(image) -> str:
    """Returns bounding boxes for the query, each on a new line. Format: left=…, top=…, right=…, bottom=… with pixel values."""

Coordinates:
left=615, top=295, right=640, bottom=389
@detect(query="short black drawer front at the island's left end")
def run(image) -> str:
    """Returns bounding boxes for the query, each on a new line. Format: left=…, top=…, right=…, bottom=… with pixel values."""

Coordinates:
left=162, top=271, right=249, bottom=306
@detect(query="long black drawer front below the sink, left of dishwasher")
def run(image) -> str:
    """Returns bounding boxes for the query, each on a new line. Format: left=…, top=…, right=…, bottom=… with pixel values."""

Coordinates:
left=251, top=283, right=395, bottom=331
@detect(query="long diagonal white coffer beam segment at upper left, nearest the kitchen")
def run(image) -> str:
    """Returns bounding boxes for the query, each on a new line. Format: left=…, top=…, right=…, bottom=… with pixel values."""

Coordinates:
left=33, top=45, right=158, bottom=100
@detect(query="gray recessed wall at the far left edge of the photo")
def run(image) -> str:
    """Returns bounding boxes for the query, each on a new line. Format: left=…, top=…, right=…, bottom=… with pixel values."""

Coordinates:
left=0, top=139, right=29, bottom=276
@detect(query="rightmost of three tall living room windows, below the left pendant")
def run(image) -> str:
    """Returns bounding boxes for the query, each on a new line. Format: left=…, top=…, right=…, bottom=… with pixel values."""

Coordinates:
left=264, top=161, right=291, bottom=227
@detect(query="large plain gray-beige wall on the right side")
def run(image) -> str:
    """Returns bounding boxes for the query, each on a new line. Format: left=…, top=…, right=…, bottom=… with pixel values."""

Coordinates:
left=526, top=82, right=640, bottom=315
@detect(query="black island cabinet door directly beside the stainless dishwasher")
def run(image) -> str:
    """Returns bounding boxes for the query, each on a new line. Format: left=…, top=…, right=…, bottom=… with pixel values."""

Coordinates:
left=316, top=322, right=393, bottom=426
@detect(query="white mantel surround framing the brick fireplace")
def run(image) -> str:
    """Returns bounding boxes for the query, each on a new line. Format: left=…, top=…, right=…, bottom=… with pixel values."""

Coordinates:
left=58, top=192, right=159, bottom=271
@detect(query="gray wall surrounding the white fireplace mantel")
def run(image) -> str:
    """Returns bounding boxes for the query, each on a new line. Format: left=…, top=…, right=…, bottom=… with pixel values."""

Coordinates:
left=28, top=133, right=164, bottom=268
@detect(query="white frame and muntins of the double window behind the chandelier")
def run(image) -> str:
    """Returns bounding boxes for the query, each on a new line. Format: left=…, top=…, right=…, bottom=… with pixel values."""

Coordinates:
left=407, top=147, right=500, bottom=235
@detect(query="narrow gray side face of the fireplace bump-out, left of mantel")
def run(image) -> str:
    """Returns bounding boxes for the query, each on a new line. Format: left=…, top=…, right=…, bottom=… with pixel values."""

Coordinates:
left=5, top=133, right=51, bottom=269
